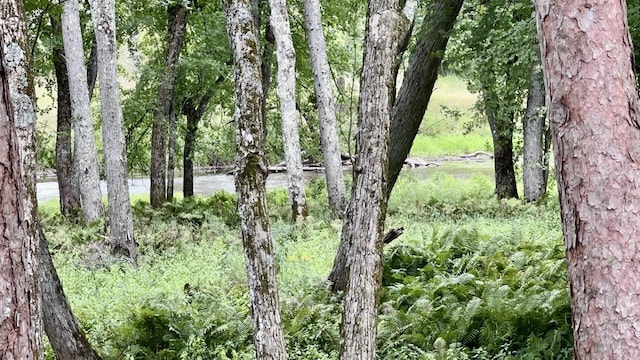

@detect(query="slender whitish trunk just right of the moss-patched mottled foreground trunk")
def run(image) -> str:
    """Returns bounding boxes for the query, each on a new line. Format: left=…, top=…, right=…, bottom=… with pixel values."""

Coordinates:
left=269, top=0, right=308, bottom=222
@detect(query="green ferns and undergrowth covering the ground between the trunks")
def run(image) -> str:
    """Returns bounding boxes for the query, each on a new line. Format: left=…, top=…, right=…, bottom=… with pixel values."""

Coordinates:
left=41, top=172, right=572, bottom=360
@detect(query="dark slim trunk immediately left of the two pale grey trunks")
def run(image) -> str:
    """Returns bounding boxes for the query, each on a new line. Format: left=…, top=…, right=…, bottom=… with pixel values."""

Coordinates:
left=50, top=15, right=82, bottom=223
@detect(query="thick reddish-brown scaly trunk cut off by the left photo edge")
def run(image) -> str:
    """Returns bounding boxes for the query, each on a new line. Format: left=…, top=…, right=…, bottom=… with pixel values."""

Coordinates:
left=0, top=0, right=43, bottom=359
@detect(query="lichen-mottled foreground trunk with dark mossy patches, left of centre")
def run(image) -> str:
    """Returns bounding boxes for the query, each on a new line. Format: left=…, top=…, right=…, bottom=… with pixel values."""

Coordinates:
left=222, top=0, right=287, bottom=360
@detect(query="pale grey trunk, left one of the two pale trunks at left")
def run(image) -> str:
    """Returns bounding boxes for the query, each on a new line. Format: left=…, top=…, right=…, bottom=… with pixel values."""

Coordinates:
left=62, top=0, right=103, bottom=223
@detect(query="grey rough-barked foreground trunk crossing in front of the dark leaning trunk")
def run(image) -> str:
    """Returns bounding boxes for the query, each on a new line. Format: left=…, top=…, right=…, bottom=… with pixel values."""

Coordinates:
left=340, top=0, right=410, bottom=360
